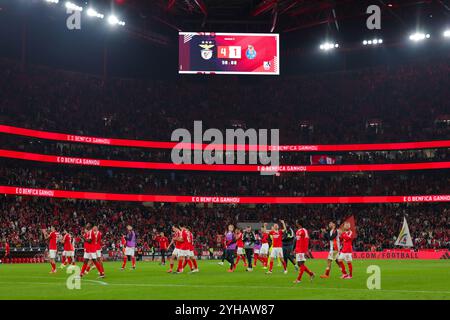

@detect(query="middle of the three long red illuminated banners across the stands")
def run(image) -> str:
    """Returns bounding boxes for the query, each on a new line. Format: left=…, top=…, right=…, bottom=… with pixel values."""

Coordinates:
left=0, top=149, right=450, bottom=172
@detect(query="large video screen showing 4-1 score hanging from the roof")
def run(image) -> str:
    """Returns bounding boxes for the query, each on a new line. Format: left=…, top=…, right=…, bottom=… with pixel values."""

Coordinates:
left=179, top=32, right=280, bottom=75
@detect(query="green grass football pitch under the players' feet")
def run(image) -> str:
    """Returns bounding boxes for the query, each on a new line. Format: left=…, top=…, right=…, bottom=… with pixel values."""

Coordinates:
left=0, top=260, right=450, bottom=300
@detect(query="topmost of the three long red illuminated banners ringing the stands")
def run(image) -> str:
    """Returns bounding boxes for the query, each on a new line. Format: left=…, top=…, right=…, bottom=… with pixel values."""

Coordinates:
left=0, top=125, right=450, bottom=152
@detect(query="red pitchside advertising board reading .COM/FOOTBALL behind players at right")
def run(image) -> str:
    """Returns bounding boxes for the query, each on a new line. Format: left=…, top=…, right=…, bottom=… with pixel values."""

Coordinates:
left=311, top=250, right=450, bottom=260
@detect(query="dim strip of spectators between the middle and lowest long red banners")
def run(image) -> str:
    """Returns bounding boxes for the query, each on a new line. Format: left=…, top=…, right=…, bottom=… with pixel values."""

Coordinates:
left=0, top=164, right=450, bottom=197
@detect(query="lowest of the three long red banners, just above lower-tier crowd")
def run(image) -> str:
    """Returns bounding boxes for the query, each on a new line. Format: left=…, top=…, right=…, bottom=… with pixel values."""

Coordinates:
left=0, top=186, right=450, bottom=204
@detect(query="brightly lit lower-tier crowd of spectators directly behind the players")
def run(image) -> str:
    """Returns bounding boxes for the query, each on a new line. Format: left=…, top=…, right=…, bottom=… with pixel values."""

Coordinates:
left=0, top=196, right=450, bottom=252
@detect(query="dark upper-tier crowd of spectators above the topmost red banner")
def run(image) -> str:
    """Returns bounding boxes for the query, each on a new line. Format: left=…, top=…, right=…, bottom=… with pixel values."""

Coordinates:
left=0, top=57, right=450, bottom=144
